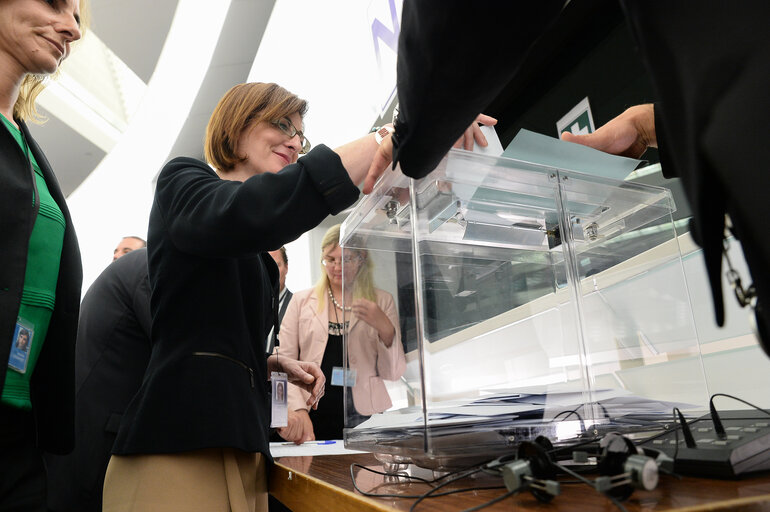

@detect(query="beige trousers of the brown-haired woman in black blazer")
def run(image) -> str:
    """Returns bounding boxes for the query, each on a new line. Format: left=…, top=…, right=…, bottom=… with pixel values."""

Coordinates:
left=102, top=448, right=267, bottom=512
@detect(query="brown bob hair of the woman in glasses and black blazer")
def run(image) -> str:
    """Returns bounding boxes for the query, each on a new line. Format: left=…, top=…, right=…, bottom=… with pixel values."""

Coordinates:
left=204, top=82, right=307, bottom=172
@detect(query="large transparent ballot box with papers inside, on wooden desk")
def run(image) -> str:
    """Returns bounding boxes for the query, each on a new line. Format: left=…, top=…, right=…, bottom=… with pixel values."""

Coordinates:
left=336, top=150, right=708, bottom=468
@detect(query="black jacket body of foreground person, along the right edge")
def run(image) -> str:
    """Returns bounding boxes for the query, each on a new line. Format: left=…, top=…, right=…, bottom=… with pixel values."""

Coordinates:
left=622, top=0, right=770, bottom=344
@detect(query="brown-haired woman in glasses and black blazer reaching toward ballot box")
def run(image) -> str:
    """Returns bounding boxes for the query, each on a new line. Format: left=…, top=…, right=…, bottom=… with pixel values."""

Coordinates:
left=103, top=83, right=390, bottom=512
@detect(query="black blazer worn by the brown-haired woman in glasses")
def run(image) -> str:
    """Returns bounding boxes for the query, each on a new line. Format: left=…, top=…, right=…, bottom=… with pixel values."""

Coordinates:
left=113, top=146, right=359, bottom=456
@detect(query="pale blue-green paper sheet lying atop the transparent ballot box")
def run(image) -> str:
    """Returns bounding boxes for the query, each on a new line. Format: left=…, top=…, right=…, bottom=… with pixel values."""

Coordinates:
left=503, top=130, right=642, bottom=180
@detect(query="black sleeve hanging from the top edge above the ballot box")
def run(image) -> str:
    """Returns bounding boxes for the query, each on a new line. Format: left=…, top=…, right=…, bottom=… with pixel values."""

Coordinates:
left=393, top=0, right=565, bottom=178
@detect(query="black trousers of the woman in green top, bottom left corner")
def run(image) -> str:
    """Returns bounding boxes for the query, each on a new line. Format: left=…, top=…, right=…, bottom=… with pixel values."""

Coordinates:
left=0, top=405, right=47, bottom=512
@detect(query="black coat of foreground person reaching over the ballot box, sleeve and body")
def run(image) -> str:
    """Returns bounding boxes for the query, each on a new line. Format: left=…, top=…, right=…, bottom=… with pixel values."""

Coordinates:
left=393, top=0, right=770, bottom=348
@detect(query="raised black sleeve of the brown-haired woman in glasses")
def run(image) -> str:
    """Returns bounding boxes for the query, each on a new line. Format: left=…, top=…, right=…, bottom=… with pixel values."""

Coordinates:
left=153, top=146, right=359, bottom=257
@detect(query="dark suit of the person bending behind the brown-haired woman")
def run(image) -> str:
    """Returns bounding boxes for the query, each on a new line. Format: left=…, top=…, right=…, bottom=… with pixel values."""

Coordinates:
left=47, top=249, right=151, bottom=512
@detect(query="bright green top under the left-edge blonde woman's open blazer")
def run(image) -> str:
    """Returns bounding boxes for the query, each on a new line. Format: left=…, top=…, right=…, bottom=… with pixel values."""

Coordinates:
left=0, top=114, right=66, bottom=410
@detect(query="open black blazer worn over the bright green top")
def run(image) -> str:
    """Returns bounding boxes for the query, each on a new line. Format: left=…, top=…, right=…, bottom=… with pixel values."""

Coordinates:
left=0, top=120, right=83, bottom=453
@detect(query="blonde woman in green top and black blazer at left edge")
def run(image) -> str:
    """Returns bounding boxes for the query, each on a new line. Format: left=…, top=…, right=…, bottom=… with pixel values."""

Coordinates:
left=0, top=0, right=85, bottom=511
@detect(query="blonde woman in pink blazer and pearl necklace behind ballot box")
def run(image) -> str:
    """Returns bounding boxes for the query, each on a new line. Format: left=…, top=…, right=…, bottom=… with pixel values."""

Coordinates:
left=278, top=224, right=406, bottom=444
